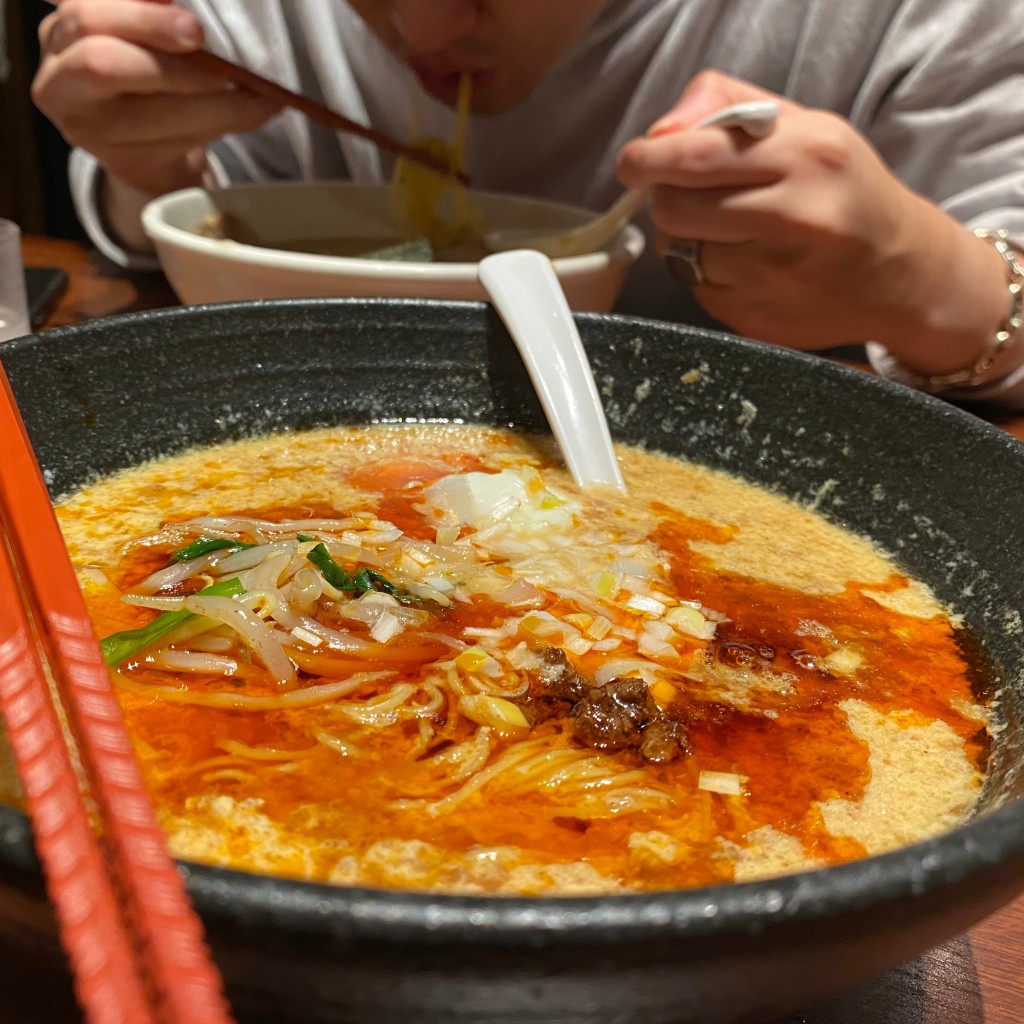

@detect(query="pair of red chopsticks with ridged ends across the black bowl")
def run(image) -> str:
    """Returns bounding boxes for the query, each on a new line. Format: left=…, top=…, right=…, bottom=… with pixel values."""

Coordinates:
left=0, top=367, right=230, bottom=1024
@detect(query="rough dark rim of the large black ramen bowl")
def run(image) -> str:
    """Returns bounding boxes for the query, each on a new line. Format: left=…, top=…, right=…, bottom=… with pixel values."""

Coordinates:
left=8, top=297, right=1024, bottom=949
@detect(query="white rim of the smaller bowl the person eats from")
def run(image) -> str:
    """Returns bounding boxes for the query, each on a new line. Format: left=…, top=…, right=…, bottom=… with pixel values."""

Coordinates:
left=141, top=180, right=647, bottom=283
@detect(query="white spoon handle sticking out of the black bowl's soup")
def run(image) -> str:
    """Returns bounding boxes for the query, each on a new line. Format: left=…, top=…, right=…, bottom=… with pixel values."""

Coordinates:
left=477, top=249, right=626, bottom=490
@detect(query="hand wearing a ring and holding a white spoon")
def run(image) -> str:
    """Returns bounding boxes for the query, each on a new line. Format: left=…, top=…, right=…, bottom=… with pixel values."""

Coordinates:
left=617, top=72, right=974, bottom=349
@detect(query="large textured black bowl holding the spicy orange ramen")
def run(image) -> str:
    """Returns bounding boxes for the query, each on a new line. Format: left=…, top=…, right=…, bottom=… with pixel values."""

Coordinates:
left=0, top=300, right=1024, bottom=1024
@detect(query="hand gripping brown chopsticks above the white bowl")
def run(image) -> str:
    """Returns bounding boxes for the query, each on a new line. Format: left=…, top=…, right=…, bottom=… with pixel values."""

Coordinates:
left=32, top=0, right=278, bottom=196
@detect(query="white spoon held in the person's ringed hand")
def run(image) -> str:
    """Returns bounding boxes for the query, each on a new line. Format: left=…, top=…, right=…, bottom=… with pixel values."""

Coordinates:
left=483, top=99, right=778, bottom=259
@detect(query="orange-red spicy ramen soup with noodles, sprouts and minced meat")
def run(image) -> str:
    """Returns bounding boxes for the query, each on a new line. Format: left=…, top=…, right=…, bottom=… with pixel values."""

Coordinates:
left=51, top=426, right=986, bottom=895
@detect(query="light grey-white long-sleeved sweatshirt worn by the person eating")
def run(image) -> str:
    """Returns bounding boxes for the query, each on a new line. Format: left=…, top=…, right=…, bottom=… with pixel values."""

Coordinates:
left=71, top=0, right=1024, bottom=408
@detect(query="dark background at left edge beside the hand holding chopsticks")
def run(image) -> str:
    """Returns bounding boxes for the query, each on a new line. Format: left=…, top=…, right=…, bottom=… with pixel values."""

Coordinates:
left=0, top=0, right=85, bottom=239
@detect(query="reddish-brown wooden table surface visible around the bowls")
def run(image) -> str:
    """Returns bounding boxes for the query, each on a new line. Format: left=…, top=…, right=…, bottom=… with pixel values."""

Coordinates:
left=14, top=237, right=1024, bottom=1024
